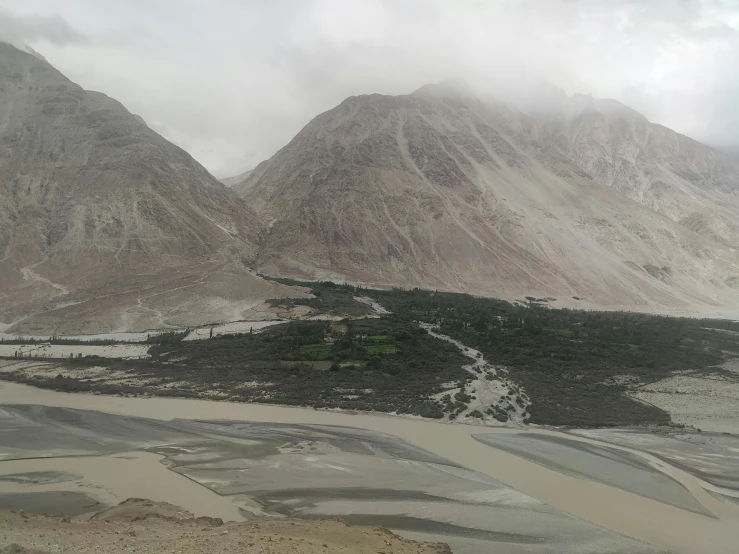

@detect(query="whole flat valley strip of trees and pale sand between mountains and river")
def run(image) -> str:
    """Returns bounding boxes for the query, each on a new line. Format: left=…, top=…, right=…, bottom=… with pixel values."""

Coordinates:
left=0, top=279, right=739, bottom=426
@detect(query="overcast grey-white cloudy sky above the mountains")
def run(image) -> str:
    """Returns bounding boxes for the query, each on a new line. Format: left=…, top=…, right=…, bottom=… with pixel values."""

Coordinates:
left=0, top=0, right=739, bottom=177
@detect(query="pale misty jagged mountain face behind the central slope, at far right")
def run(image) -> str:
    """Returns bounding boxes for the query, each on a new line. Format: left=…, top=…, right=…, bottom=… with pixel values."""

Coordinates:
left=533, top=91, right=739, bottom=245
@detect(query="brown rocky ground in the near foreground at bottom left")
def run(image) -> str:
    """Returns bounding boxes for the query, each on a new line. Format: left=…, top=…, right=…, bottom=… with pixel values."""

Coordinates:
left=0, top=499, right=451, bottom=554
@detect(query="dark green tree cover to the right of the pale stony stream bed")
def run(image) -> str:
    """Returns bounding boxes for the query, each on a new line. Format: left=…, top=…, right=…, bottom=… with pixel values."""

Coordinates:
left=370, top=289, right=739, bottom=426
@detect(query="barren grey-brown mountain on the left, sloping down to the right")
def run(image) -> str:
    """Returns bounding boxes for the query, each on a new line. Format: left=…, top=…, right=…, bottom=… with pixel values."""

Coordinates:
left=0, top=44, right=302, bottom=331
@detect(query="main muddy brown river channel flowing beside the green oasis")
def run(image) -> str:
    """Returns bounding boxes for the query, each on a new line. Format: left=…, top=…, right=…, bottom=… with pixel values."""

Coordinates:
left=0, top=383, right=739, bottom=554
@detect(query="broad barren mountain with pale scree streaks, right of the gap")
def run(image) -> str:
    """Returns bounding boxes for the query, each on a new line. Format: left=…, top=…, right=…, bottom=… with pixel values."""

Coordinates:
left=235, top=84, right=739, bottom=308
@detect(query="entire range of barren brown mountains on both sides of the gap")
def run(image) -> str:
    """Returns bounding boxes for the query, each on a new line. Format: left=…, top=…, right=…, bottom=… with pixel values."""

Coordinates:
left=0, top=44, right=739, bottom=334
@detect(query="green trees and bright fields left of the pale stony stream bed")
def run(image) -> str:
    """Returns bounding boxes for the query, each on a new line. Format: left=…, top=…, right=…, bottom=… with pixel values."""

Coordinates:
left=30, top=317, right=470, bottom=418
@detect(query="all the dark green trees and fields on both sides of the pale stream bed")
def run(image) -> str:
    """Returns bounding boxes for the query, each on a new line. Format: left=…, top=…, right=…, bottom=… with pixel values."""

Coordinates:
left=3, top=280, right=739, bottom=426
